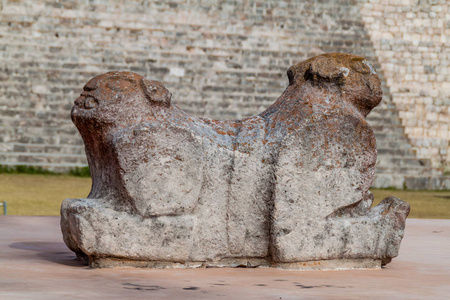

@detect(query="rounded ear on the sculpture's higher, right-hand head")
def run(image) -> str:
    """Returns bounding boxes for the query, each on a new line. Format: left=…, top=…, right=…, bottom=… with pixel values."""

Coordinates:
left=305, top=56, right=350, bottom=85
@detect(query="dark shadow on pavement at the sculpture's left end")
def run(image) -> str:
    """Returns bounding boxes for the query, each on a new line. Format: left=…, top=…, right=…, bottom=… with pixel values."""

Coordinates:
left=9, top=242, right=87, bottom=268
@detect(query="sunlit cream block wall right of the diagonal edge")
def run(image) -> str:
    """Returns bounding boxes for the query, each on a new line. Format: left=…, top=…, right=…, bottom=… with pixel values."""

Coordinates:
left=359, top=0, right=450, bottom=170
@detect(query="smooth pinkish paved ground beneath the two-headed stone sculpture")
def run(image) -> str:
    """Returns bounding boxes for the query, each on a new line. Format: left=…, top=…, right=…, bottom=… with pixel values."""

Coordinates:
left=0, top=216, right=450, bottom=300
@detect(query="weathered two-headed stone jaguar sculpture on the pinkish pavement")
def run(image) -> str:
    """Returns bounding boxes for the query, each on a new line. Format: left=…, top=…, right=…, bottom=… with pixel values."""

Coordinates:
left=61, top=53, right=410, bottom=269
